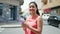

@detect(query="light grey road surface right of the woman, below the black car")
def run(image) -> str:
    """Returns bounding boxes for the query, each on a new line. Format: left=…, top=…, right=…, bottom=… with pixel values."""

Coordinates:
left=42, top=25, right=60, bottom=34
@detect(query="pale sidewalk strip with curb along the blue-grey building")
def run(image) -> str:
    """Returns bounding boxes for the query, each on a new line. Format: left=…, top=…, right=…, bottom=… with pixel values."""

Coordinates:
left=0, top=21, right=21, bottom=28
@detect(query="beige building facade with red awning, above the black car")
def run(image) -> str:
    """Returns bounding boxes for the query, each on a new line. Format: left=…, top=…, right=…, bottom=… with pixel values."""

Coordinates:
left=42, top=0, right=60, bottom=15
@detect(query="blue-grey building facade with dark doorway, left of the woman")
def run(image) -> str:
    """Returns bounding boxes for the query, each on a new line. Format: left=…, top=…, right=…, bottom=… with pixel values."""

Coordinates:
left=0, top=0, right=23, bottom=21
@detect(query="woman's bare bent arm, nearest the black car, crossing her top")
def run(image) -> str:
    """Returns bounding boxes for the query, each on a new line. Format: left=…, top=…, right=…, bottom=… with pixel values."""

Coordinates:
left=26, top=17, right=43, bottom=33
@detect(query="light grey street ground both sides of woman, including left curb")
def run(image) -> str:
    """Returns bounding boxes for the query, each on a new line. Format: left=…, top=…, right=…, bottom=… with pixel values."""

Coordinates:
left=0, top=21, right=60, bottom=34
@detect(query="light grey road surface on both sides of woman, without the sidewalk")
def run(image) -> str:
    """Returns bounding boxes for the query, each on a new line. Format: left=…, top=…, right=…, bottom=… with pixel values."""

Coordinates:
left=0, top=25, right=60, bottom=34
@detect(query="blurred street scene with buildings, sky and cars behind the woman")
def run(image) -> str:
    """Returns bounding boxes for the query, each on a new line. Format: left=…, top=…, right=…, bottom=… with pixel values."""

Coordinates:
left=0, top=0, right=60, bottom=34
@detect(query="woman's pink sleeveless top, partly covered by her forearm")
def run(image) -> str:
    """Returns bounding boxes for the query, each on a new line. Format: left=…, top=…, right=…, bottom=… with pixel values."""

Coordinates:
left=25, top=17, right=37, bottom=34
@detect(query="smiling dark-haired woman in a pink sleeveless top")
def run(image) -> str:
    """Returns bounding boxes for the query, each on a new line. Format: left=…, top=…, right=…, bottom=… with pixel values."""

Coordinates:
left=22, top=2, right=43, bottom=34
